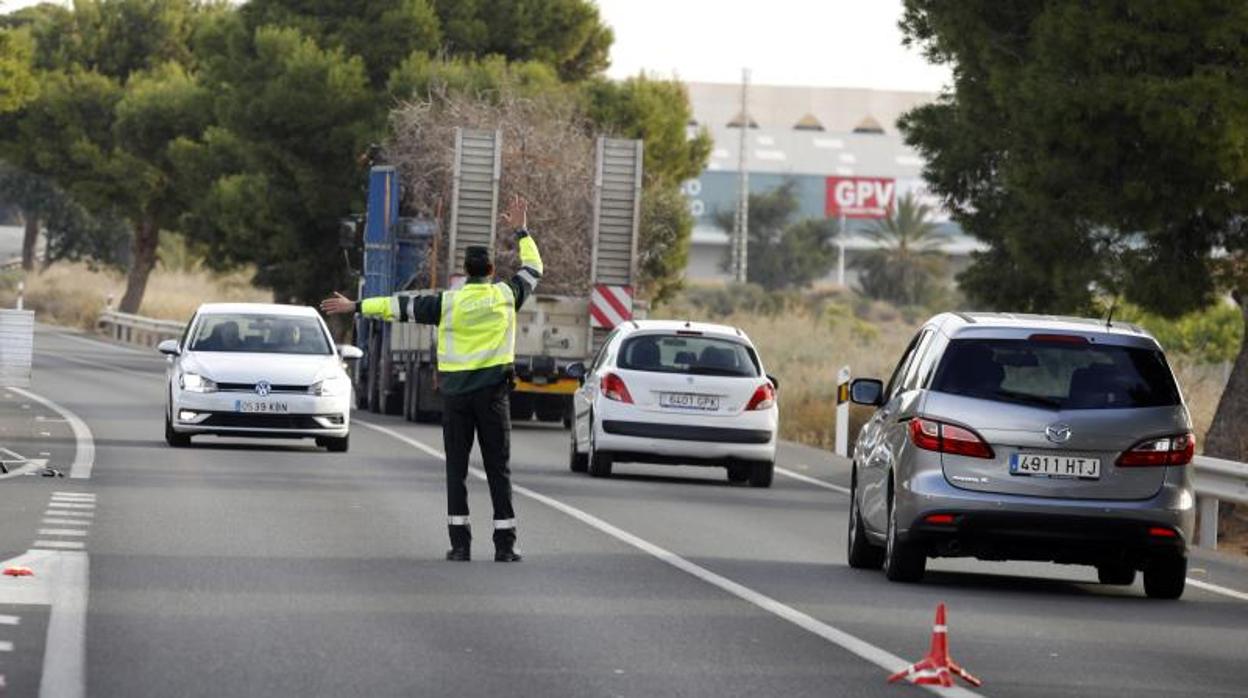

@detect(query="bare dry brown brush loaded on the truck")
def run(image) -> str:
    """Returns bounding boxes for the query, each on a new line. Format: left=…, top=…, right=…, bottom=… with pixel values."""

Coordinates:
left=386, top=87, right=594, bottom=295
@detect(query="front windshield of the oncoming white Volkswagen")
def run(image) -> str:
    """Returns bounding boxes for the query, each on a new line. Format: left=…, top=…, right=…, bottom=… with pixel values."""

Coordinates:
left=191, top=313, right=332, bottom=355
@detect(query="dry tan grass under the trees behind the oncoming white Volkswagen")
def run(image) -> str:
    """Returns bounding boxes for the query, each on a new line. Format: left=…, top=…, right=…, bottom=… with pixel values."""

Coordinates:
left=0, top=263, right=272, bottom=330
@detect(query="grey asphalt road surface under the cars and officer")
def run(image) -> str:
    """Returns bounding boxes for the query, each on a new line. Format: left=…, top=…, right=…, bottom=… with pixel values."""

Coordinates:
left=0, top=327, right=1248, bottom=698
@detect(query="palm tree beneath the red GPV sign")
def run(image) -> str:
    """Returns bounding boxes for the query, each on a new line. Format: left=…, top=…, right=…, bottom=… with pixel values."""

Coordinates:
left=852, top=194, right=948, bottom=306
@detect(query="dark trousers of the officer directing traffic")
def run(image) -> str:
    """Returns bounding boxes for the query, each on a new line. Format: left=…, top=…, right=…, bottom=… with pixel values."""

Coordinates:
left=442, top=381, right=515, bottom=548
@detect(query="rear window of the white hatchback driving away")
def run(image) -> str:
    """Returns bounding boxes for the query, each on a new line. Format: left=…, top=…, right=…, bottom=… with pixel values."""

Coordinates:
left=618, top=335, right=759, bottom=377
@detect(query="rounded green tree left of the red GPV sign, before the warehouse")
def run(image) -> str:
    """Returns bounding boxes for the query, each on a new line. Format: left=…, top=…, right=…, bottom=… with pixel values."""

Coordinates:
left=715, top=181, right=837, bottom=291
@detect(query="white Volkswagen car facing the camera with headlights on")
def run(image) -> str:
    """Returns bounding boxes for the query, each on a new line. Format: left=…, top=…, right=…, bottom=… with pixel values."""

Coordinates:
left=157, top=303, right=362, bottom=452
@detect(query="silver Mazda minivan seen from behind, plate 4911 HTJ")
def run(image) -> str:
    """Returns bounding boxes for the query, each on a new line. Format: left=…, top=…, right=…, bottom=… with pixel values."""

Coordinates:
left=849, top=313, right=1196, bottom=598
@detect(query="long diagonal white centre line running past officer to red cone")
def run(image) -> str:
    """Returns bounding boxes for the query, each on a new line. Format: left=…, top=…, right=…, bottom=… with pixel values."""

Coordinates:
left=354, top=420, right=978, bottom=697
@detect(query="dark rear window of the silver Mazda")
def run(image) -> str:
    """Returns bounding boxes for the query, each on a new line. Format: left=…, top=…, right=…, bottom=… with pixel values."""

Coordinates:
left=932, top=340, right=1179, bottom=410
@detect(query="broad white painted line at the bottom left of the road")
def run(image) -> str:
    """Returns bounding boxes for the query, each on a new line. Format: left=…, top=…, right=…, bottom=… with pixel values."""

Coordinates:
left=39, top=552, right=90, bottom=698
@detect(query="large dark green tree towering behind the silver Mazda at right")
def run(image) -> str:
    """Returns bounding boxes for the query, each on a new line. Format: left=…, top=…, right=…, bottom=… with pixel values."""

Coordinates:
left=902, top=0, right=1248, bottom=458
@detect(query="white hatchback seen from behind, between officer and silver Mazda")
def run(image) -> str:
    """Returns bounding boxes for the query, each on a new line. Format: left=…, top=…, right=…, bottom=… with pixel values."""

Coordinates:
left=569, top=320, right=780, bottom=487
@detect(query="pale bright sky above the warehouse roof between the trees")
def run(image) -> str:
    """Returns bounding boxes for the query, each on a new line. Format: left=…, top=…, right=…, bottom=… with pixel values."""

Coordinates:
left=0, top=0, right=950, bottom=92
